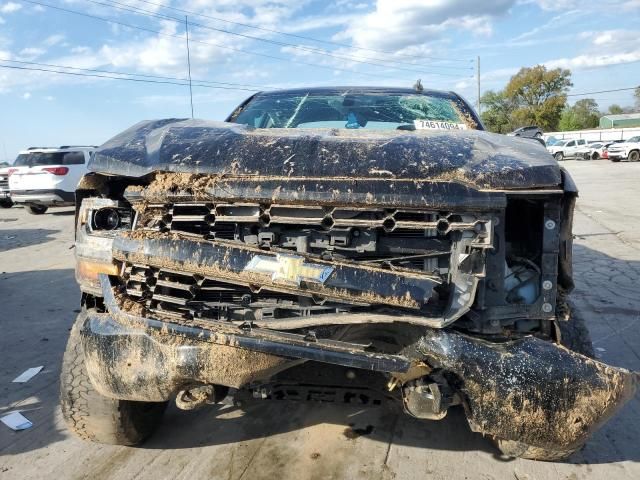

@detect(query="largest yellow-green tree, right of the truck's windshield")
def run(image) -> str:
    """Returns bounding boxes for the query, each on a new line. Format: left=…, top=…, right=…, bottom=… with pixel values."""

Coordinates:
left=504, top=65, right=573, bottom=131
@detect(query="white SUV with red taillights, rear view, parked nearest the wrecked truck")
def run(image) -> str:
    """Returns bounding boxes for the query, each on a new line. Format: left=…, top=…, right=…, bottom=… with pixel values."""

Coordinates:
left=9, top=146, right=96, bottom=215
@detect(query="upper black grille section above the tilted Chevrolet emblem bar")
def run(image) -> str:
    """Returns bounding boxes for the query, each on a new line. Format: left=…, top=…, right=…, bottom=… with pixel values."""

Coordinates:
left=136, top=203, right=489, bottom=274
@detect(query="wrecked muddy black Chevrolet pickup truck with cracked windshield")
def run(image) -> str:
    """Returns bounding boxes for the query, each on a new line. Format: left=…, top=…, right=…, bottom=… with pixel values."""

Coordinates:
left=61, top=87, right=638, bottom=460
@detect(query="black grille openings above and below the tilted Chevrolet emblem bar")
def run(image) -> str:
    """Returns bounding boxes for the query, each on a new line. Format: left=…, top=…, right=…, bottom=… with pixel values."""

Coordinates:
left=123, top=202, right=491, bottom=320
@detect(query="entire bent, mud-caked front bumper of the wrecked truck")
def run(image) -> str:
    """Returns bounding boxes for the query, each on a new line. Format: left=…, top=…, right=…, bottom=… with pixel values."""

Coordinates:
left=81, top=275, right=638, bottom=450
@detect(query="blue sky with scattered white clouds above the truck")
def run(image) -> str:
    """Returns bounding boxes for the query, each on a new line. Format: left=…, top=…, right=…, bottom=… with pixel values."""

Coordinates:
left=0, top=0, right=640, bottom=162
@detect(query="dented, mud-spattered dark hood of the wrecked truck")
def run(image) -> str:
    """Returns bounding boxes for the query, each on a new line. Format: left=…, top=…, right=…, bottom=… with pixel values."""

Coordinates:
left=89, top=119, right=561, bottom=190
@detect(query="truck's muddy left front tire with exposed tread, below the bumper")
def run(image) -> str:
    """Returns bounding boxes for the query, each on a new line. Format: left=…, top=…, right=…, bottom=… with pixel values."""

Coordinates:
left=60, top=314, right=167, bottom=445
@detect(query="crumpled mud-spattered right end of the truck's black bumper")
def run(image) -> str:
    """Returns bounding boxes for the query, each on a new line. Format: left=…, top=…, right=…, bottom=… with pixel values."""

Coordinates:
left=414, top=330, right=639, bottom=451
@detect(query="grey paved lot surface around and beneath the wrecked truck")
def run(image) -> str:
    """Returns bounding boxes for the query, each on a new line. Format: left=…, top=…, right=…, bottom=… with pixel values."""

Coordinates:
left=0, top=161, right=640, bottom=480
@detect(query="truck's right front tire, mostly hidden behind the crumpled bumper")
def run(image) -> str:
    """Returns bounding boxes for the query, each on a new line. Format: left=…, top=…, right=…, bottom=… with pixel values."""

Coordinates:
left=493, top=295, right=595, bottom=462
